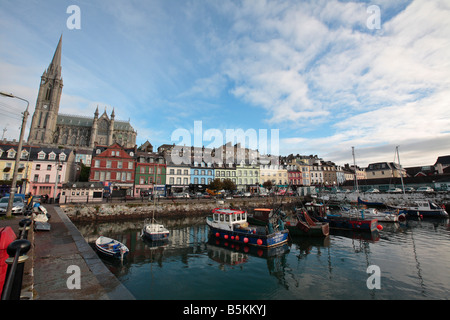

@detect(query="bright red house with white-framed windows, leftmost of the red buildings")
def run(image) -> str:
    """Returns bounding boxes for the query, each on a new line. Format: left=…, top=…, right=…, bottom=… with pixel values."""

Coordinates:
left=89, top=143, right=135, bottom=196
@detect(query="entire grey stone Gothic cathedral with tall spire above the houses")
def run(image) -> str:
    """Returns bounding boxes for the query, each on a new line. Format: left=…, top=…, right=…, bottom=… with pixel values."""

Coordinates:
left=28, top=36, right=137, bottom=149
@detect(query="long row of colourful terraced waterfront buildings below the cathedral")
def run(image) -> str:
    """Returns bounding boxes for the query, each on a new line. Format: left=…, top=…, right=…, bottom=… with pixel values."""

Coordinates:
left=0, top=142, right=450, bottom=197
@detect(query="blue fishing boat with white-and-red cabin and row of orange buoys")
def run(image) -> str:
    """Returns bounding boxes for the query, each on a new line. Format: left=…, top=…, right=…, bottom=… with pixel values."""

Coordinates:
left=206, top=208, right=289, bottom=248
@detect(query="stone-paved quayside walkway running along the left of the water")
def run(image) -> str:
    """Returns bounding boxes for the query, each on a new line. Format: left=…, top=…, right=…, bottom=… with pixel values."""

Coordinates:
left=0, top=205, right=135, bottom=300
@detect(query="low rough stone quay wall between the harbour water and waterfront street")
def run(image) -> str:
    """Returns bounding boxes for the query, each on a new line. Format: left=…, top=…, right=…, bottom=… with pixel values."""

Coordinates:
left=60, top=197, right=302, bottom=222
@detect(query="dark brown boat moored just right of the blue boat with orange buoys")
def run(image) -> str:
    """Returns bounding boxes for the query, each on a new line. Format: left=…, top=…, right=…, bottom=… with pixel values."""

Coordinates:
left=285, top=210, right=330, bottom=237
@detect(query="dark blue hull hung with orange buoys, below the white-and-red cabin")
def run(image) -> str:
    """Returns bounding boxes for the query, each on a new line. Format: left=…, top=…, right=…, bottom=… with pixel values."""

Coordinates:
left=209, top=225, right=289, bottom=248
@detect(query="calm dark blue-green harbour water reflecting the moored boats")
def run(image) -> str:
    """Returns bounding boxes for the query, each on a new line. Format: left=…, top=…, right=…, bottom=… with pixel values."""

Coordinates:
left=76, top=217, right=450, bottom=300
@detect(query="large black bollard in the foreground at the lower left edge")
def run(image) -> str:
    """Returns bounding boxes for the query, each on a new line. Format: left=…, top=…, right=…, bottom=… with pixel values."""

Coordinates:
left=2, top=239, right=31, bottom=300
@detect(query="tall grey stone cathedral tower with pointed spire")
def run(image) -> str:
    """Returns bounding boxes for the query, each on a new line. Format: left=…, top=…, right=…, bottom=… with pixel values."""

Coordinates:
left=28, top=35, right=63, bottom=144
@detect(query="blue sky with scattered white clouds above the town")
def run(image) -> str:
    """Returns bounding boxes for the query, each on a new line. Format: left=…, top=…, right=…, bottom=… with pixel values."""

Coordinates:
left=0, top=0, right=450, bottom=167
